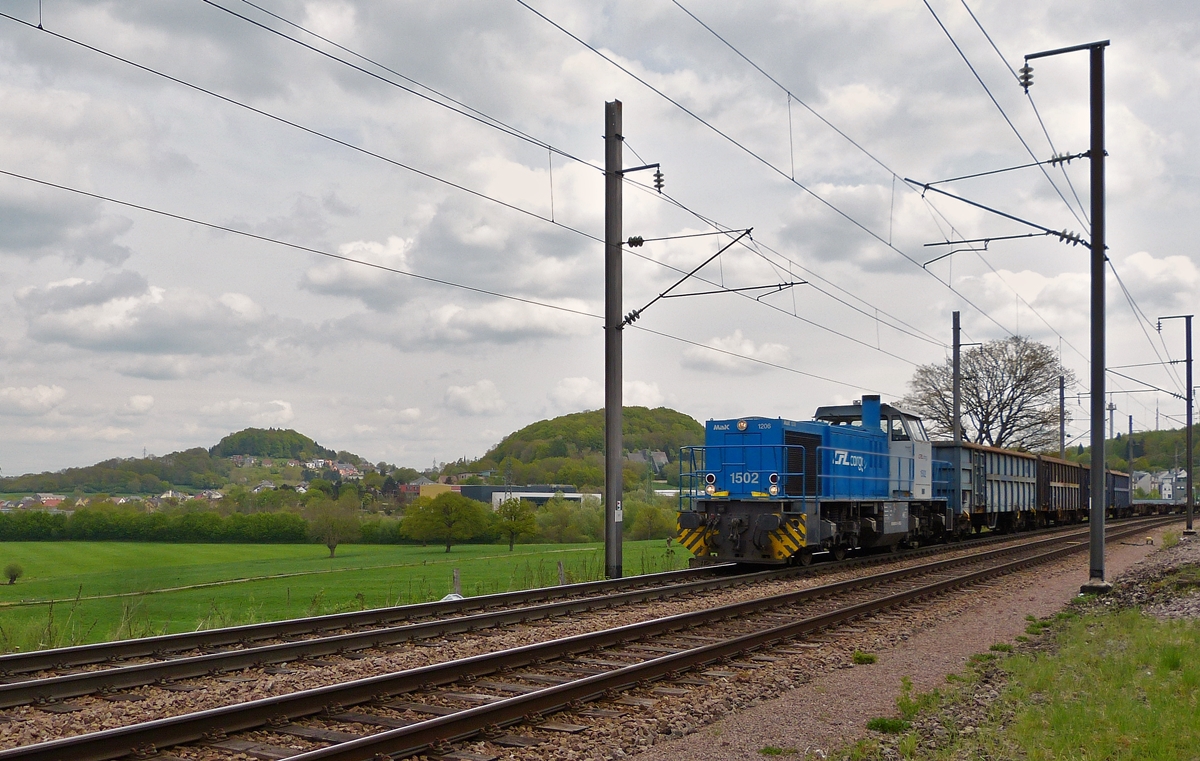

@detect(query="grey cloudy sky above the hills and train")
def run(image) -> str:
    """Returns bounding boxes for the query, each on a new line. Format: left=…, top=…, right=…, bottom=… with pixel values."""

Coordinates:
left=0, top=0, right=1200, bottom=474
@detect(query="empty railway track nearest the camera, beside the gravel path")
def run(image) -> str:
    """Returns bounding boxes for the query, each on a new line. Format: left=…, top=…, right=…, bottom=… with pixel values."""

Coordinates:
left=0, top=519, right=1177, bottom=761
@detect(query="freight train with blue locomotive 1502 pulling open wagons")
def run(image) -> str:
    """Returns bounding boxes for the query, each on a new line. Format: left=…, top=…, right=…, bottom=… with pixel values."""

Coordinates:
left=678, top=395, right=1160, bottom=565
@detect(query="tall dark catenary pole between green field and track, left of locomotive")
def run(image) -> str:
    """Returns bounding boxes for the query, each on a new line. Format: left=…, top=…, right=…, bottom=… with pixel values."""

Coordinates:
left=604, top=101, right=624, bottom=579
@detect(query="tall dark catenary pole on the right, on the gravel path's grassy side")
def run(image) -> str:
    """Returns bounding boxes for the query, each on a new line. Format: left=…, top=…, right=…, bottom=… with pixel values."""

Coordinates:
left=1020, top=40, right=1112, bottom=593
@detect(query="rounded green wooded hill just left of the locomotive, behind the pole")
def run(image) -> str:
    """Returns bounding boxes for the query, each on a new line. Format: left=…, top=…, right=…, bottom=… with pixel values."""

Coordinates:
left=445, top=407, right=704, bottom=490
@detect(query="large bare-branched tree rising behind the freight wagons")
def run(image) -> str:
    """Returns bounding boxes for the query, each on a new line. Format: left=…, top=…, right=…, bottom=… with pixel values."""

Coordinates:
left=900, top=336, right=1075, bottom=450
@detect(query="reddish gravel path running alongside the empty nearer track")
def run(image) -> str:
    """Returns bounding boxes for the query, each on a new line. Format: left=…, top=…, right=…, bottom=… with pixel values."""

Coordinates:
left=624, top=522, right=1185, bottom=761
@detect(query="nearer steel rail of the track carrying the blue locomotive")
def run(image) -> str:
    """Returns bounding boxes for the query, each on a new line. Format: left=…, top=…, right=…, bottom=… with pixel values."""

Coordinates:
left=0, top=518, right=1113, bottom=708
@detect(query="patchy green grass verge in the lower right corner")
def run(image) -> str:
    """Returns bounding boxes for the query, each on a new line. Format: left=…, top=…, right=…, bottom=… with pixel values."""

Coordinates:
left=830, top=604, right=1200, bottom=761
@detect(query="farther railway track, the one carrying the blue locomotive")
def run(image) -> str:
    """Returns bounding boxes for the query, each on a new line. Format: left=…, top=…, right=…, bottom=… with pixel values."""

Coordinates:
left=0, top=518, right=1089, bottom=708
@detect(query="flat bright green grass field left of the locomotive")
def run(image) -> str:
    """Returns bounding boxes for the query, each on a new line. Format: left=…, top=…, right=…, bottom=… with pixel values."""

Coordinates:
left=0, top=540, right=688, bottom=652
